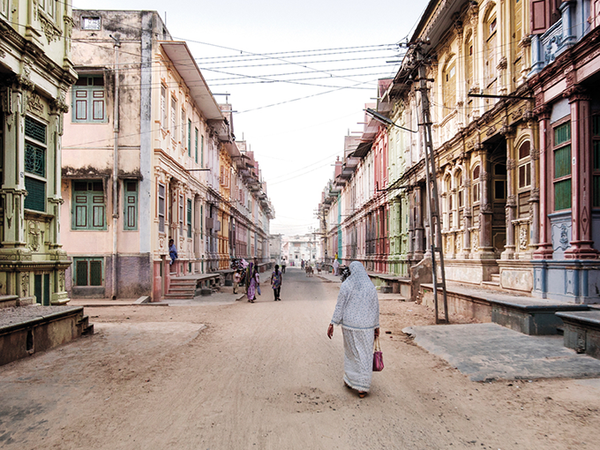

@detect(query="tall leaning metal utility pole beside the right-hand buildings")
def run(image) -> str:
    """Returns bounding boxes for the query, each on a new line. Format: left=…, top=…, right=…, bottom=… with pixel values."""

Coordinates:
left=412, top=40, right=449, bottom=323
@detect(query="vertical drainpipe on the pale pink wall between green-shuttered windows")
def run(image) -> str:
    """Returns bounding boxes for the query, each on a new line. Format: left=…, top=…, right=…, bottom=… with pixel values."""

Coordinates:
left=110, top=35, right=121, bottom=300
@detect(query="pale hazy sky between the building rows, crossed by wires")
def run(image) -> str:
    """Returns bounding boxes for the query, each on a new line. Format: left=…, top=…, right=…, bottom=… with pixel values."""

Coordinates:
left=73, top=0, right=427, bottom=235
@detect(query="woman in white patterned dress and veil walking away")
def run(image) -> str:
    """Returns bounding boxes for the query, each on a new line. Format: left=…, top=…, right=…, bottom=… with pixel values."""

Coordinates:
left=327, top=261, right=379, bottom=398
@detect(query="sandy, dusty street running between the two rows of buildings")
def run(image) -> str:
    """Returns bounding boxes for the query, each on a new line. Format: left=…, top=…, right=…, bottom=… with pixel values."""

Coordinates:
left=0, top=269, right=600, bottom=450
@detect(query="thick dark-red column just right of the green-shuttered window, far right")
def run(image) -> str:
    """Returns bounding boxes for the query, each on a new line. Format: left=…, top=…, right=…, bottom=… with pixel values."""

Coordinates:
left=564, top=85, right=599, bottom=259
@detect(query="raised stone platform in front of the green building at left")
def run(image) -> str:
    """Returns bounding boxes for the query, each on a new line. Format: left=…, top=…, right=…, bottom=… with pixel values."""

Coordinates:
left=0, top=306, right=94, bottom=365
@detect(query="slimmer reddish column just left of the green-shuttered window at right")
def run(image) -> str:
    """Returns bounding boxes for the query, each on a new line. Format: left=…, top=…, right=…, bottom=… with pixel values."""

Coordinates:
left=533, top=100, right=553, bottom=259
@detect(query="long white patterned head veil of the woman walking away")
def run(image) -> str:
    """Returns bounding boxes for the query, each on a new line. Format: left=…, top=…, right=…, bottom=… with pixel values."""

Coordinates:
left=331, top=261, right=379, bottom=329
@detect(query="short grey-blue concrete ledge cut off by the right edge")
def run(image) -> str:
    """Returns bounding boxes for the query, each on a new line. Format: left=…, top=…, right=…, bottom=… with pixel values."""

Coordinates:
left=556, top=310, right=600, bottom=358
